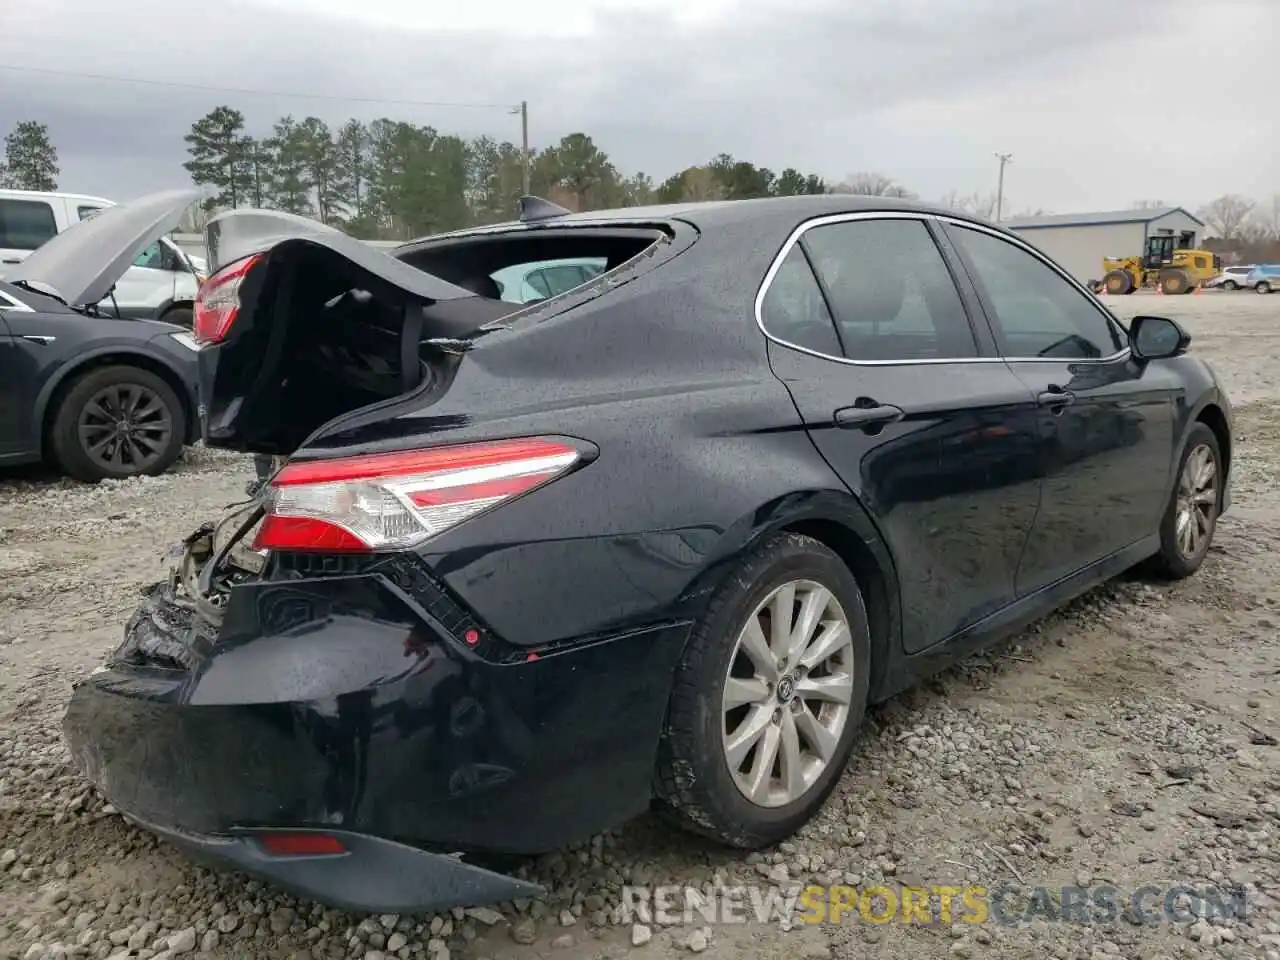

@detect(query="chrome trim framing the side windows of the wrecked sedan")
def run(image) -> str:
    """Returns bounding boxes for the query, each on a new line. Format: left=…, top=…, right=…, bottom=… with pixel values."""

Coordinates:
left=755, top=210, right=1130, bottom=366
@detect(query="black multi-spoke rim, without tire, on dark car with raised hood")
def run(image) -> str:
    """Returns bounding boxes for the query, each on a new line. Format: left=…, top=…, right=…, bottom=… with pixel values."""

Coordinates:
left=77, top=383, right=173, bottom=474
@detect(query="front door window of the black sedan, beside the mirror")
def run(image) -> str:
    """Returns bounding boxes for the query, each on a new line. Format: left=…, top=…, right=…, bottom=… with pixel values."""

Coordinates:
left=951, top=227, right=1123, bottom=360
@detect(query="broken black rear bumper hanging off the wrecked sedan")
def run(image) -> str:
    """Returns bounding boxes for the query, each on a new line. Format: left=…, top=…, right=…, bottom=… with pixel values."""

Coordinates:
left=63, top=555, right=687, bottom=913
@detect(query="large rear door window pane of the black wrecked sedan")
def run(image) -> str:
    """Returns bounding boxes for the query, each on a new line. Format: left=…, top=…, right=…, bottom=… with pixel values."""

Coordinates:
left=800, top=219, right=978, bottom=362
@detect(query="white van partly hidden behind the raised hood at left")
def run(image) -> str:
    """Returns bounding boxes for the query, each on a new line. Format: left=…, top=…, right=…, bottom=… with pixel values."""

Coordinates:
left=0, top=189, right=206, bottom=328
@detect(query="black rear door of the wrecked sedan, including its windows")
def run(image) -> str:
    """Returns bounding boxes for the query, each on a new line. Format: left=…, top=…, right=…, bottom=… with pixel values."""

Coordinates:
left=758, top=214, right=1041, bottom=652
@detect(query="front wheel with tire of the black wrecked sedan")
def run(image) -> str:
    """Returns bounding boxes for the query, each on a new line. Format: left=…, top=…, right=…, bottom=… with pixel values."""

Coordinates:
left=1152, top=424, right=1225, bottom=580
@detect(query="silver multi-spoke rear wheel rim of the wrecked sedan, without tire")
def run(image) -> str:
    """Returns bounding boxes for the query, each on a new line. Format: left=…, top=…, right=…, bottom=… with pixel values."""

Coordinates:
left=722, top=580, right=854, bottom=808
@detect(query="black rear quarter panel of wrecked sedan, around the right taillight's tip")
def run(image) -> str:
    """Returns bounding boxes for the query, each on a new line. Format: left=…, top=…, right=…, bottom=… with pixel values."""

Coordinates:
left=299, top=224, right=875, bottom=646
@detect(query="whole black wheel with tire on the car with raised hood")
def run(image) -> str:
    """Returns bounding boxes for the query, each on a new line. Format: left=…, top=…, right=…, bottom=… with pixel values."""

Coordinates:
left=51, top=366, right=186, bottom=483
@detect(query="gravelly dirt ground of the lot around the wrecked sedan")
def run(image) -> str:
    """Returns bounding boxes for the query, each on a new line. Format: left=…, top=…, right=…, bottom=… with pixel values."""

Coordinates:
left=0, top=293, right=1280, bottom=960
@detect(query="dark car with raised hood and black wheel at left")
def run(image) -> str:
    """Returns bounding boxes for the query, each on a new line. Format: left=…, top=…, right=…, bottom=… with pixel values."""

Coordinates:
left=0, top=191, right=200, bottom=483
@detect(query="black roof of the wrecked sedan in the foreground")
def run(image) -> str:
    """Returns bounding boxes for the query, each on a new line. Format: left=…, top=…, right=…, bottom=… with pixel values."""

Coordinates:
left=404, top=193, right=986, bottom=247
